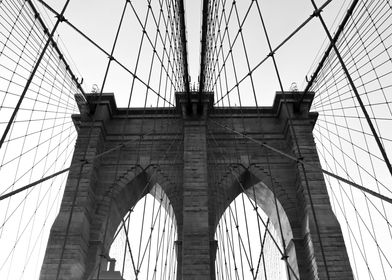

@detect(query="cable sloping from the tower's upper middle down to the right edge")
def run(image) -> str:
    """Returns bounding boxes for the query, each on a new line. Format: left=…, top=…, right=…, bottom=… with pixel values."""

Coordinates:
left=210, top=120, right=392, bottom=204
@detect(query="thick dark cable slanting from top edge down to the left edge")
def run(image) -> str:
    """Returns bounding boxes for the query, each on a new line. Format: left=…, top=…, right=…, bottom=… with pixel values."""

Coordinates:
left=0, top=0, right=70, bottom=149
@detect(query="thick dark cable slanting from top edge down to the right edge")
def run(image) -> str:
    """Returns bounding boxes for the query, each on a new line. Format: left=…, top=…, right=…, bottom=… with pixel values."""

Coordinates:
left=311, top=0, right=392, bottom=179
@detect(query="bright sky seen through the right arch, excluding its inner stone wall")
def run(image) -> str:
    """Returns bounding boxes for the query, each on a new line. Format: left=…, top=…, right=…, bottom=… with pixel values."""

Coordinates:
left=215, top=193, right=288, bottom=280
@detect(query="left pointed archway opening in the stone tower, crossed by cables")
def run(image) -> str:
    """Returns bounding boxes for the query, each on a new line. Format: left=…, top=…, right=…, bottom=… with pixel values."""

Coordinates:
left=107, top=184, right=177, bottom=280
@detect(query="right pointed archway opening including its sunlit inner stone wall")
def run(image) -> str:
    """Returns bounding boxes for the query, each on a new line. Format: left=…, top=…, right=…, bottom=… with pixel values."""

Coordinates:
left=215, top=174, right=299, bottom=280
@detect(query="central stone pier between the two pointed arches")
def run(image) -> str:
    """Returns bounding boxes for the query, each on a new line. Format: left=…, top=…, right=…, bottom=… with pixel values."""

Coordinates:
left=182, top=120, right=211, bottom=280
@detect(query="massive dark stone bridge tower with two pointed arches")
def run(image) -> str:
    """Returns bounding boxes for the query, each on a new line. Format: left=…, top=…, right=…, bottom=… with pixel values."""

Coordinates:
left=40, top=92, right=353, bottom=280
